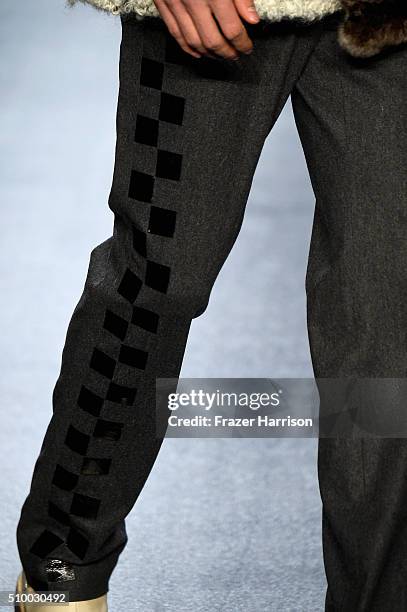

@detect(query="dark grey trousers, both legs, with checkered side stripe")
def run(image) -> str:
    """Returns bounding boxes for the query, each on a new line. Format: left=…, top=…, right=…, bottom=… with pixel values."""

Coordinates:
left=17, top=14, right=407, bottom=612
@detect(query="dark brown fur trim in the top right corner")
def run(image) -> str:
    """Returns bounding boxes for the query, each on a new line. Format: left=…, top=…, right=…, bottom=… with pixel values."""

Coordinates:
left=338, top=0, right=407, bottom=57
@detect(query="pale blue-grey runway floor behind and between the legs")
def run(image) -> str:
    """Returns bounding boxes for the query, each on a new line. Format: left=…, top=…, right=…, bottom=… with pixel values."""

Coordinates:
left=0, top=0, right=325, bottom=612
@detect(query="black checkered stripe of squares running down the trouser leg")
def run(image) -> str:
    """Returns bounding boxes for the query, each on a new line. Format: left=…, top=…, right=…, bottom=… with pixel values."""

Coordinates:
left=30, top=28, right=186, bottom=581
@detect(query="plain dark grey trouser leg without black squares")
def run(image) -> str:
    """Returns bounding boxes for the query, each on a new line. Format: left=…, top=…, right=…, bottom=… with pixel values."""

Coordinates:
left=292, top=15, right=407, bottom=612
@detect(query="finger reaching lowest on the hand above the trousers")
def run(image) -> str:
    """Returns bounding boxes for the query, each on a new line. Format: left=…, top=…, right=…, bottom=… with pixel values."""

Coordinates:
left=188, top=2, right=239, bottom=59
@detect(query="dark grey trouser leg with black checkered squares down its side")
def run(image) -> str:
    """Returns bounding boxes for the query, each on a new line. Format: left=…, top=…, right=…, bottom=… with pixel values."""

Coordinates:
left=17, top=17, right=320, bottom=601
